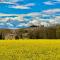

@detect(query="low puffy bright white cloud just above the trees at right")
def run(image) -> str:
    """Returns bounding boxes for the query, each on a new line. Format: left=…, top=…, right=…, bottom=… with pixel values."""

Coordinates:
left=29, top=16, right=60, bottom=27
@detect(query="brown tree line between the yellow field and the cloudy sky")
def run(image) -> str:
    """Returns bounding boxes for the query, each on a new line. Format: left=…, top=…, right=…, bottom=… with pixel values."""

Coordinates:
left=0, top=25, right=60, bottom=39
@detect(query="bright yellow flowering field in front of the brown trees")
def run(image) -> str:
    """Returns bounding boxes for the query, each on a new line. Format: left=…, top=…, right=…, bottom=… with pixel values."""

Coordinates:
left=0, top=39, right=60, bottom=60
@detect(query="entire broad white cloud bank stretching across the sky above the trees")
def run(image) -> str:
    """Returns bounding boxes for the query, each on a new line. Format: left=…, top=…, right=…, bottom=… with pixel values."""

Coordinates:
left=0, top=9, right=60, bottom=28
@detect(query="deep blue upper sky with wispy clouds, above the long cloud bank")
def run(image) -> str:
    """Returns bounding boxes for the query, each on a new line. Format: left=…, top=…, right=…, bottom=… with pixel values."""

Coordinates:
left=0, top=0, right=60, bottom=14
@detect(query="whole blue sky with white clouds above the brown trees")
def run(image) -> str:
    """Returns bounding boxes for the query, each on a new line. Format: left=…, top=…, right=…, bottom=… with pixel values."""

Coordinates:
left=0, top=0, right=60, bottom=28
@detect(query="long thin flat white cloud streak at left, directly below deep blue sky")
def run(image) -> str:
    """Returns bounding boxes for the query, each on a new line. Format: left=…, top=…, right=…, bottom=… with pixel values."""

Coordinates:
left=0, top=12, right=41, bottom=17
